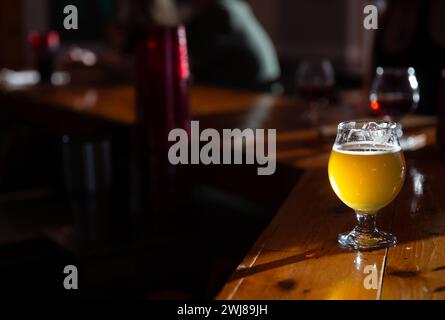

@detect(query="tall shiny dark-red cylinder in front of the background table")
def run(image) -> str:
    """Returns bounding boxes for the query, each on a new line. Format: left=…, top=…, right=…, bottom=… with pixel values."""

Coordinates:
left=134, top=26, right=190, bottom=220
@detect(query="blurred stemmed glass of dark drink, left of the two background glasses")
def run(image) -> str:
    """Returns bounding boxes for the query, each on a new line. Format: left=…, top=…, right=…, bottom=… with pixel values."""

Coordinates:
left=296, top=59, right=335, bottom=122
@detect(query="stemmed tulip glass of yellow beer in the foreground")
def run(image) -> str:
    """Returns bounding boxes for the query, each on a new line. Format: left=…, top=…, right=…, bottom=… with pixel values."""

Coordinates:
left=328, top=120, right=406, bottom=250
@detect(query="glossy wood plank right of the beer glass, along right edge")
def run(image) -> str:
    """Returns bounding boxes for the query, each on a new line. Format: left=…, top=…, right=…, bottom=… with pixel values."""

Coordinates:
left=382, top=148, right=445, bottom=299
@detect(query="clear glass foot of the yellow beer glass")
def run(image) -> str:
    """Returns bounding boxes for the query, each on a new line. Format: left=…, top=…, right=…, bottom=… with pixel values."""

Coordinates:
left=337, top=228, right=397, bottom=250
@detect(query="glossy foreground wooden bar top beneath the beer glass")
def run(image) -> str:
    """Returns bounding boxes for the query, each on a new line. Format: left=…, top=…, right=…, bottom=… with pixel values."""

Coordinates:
left=217, top=147, right=445, bottom=299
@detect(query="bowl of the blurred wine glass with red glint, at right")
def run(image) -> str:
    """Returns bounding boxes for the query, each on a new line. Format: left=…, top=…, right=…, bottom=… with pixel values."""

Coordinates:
left=369, top=67, right=420, bottom=121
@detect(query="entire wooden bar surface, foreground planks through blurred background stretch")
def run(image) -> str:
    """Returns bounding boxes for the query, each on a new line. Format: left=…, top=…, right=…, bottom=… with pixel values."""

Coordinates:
left=0, top=82, right=445, bottom=299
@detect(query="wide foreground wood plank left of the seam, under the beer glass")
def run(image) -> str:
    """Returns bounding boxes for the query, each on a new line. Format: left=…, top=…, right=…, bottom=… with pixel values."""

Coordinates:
left=217, top=169, right=393, bottom=299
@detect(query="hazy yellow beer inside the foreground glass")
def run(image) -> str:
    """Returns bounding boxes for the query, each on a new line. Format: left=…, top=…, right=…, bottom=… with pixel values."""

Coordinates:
left=328, top=142, right=406, bottom=214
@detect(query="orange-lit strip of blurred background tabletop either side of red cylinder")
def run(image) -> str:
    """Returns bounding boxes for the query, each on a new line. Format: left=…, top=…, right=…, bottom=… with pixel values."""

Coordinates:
left=0, top=85, right=288, bottom=125
